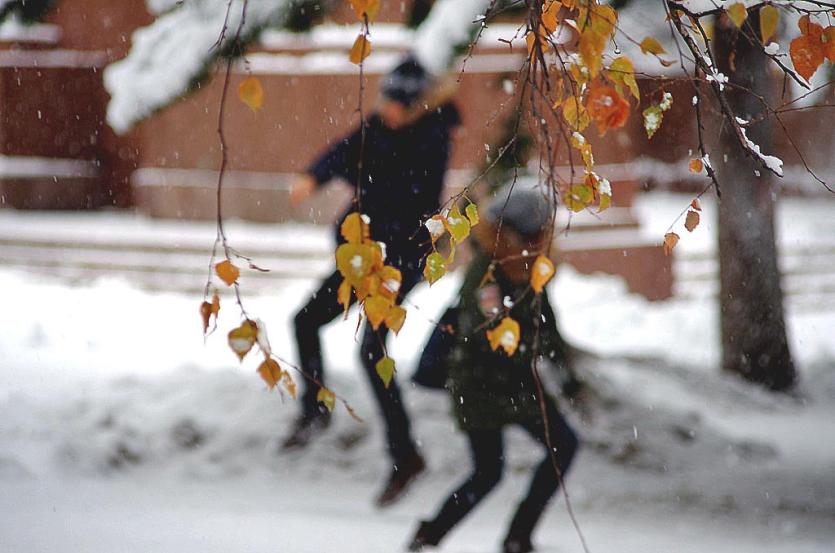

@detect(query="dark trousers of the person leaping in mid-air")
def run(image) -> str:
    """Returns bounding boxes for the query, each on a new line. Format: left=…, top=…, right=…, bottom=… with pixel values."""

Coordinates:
left=295, top=262, right=420, bottom=465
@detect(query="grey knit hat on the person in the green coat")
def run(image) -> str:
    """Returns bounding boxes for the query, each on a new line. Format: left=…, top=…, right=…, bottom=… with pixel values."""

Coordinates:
left=485, top=182, right=553, bottom=238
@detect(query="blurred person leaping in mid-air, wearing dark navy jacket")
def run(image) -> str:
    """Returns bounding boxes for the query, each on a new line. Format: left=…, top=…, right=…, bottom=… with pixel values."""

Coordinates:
left=282, top=57, right=460, bottom=507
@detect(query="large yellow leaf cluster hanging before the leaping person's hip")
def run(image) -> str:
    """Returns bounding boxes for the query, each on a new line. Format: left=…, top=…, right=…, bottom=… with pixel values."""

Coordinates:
left=336, top=213, right=406, bottom=333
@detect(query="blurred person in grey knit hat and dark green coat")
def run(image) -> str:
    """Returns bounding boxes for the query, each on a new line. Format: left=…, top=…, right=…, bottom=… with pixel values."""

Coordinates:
left=409, top=187, right=579, bottom=553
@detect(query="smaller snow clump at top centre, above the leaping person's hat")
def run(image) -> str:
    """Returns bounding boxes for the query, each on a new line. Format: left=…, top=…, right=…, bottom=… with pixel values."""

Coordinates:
left=414, top=0, right=490, bottom=74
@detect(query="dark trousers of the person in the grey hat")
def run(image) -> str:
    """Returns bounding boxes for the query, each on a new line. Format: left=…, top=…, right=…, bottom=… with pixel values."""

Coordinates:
left=428, top=401, right=579, bottom=541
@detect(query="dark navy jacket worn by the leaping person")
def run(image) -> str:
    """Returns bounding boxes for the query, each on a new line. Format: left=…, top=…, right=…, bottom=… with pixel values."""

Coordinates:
left=308, top=103, right=460, bottom=265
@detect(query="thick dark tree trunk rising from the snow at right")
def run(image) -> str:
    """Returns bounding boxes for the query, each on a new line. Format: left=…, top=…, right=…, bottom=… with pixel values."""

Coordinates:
left=714, top=10, right=796, bottom=390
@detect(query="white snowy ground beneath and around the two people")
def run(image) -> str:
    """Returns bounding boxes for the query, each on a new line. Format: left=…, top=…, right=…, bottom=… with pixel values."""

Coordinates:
left=0, top=194, right=835, bottom=553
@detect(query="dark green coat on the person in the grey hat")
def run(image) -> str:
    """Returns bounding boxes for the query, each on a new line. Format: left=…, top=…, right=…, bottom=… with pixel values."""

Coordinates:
left=447, top=252, right=565, bottom=430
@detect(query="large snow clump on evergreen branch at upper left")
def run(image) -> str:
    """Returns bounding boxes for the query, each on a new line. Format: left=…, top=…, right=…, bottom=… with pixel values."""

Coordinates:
left=104, top=0, right=295, bottom=133
